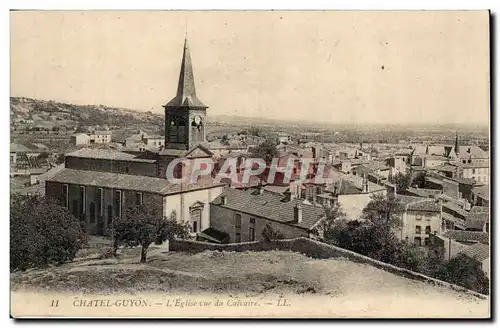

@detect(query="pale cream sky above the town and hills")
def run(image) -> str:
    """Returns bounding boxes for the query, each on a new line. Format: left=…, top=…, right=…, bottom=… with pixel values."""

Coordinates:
left=10, top=11, right=490, bottom=124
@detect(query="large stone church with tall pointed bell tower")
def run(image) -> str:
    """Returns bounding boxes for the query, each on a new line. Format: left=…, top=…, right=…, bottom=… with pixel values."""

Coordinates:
left=45, top=38, right=224, bottom=235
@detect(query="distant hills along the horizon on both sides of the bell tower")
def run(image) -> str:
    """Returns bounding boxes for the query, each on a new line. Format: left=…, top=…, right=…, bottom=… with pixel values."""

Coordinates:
left=10, top=97, right=489, bottom=138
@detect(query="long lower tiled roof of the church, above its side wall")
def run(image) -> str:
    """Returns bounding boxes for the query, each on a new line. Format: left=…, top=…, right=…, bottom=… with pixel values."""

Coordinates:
left=47, top=168, right=222, bottom=195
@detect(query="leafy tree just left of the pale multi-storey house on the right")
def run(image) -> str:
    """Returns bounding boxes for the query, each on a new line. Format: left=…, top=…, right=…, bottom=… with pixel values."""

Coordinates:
left=362, top=193, right=402, bottom=228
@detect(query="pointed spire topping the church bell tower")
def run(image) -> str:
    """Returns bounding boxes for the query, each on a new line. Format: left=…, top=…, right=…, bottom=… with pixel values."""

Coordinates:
left=167, top=36, right=207, bottom=108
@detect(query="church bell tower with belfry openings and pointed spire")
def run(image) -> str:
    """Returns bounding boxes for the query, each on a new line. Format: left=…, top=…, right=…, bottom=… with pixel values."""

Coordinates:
left=163, top=38, right=208, bottom=150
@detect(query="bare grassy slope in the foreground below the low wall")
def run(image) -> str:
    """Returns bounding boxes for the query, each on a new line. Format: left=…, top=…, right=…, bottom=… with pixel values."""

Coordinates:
left=11, top=248, right=488, bottom=317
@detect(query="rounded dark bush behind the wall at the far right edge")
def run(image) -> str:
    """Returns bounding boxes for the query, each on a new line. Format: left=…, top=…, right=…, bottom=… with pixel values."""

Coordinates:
left=436, top=254, right=490, bottom=294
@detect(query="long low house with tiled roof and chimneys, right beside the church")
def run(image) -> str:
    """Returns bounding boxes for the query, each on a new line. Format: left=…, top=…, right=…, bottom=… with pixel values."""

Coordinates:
left=209, top=188, right=325, bottom=243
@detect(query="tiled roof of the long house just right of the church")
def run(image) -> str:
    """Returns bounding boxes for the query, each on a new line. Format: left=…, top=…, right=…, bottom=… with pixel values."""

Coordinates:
left=211, top=188, right=325, bottom=230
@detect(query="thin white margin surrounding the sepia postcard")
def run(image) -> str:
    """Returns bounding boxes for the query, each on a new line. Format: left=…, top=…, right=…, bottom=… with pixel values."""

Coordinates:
left=0, top=0, right=500, bottom=327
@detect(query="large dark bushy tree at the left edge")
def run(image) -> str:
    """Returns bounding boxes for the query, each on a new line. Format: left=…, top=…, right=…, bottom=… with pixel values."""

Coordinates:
left=10, top=194, right=86, bottom=271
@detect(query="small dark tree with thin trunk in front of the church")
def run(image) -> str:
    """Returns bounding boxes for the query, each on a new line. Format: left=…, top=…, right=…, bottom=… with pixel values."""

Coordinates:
left=114, top=204, right=189, bottom=263
